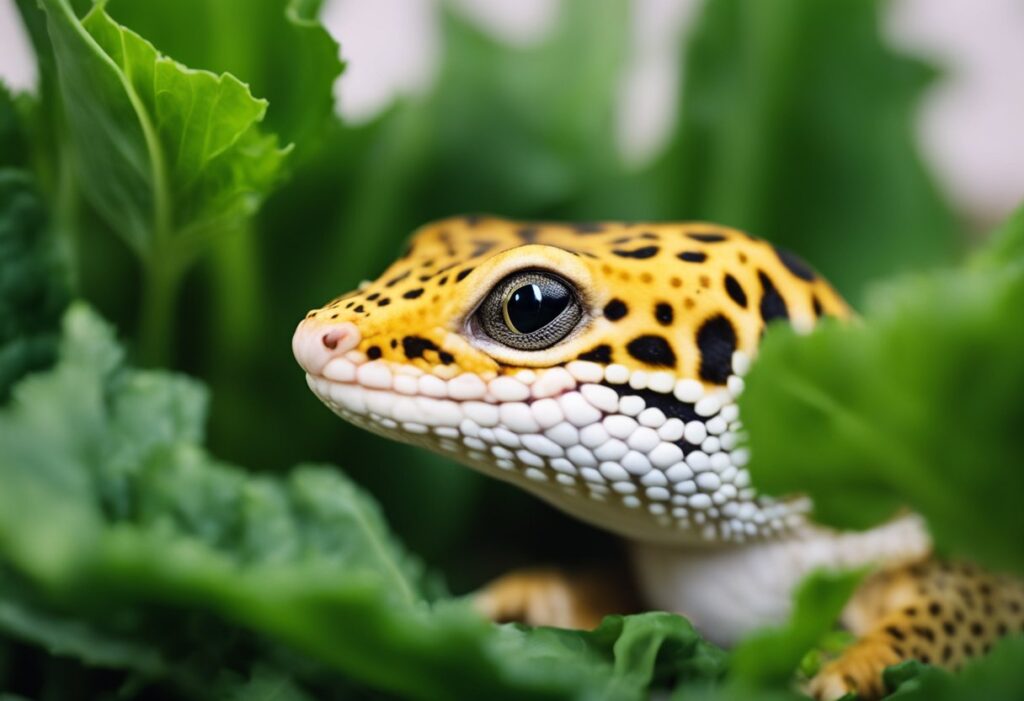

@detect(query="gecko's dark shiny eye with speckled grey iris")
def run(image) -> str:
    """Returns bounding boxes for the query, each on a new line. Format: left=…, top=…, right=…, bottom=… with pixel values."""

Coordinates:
left=477, top=270, right=583, bottom=350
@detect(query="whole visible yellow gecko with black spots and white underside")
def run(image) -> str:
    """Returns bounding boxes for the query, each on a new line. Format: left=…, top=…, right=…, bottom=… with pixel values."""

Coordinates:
left=293, top=217, right=1022, bottom=698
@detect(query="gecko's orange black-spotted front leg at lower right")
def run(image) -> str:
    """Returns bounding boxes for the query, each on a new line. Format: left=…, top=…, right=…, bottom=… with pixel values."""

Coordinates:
left=810, top=561, right=1024, bottom=699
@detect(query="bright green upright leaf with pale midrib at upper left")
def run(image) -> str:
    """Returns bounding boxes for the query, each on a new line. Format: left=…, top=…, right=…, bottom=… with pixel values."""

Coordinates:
left=42, top=0, right=286, bottom=259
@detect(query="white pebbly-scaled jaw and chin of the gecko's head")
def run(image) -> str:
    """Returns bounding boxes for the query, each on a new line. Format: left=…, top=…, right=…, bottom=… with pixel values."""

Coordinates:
left=307, top=351, right=809, bottom=543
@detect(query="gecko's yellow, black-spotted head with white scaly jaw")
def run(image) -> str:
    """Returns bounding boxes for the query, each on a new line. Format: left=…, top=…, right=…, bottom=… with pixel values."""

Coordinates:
left=293, top=217, right=848, bottom=542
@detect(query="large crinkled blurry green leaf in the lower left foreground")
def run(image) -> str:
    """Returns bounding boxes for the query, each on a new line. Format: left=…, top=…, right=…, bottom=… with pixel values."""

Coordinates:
left=0, top=306, right=724, bottom=699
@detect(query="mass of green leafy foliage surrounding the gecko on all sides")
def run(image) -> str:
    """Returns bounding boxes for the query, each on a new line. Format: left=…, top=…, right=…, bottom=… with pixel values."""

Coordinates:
left=0, top=0, right=1024, bottom=701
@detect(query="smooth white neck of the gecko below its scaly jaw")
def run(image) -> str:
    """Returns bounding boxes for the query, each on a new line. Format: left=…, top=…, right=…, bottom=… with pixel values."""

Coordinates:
left=632, top=515, right=931, bottom=645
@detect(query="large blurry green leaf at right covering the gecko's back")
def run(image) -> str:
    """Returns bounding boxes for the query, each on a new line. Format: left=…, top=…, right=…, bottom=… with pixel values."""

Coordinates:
left=740, top=215, right=1024, bottom=572
